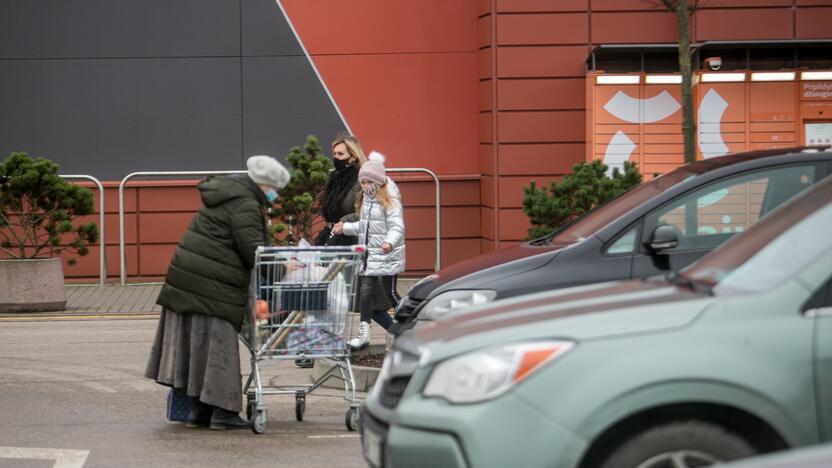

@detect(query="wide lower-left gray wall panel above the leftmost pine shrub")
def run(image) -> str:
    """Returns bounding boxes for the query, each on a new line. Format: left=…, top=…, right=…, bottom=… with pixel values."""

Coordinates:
left=0, top=58, right=242, bottom=180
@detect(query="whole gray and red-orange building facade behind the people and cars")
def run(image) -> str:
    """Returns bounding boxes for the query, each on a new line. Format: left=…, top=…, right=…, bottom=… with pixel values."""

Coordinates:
left=0, top=0, right=832, bottom=280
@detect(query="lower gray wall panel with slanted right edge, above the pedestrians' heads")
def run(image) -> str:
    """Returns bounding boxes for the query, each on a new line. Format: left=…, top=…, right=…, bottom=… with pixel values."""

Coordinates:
left=243, top=56, right=344, bottom=156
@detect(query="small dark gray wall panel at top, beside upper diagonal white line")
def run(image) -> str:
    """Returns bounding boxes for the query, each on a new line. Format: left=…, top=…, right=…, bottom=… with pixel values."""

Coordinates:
left=240, top=0, right=303, bottom=56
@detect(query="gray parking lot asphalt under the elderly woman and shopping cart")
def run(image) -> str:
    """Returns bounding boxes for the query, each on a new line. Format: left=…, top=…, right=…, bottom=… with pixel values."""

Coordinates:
left=0, top=317, right=364, bottom=468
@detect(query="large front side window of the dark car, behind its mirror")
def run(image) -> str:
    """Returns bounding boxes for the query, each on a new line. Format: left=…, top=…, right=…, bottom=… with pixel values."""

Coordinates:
left=656, top=165, right=815, bottom=251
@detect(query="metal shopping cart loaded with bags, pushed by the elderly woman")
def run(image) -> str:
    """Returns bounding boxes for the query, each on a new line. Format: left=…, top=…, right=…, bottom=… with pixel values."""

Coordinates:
left=240, top=246, right=364, bottom=434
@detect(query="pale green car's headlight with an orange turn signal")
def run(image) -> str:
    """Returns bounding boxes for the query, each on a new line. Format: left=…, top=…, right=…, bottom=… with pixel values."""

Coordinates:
left=422, top=340, right=575, bottom=403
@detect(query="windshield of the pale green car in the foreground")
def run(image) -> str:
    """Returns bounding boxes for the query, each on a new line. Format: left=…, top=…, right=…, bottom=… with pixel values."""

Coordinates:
left=680, top=178, right=832, bottom=295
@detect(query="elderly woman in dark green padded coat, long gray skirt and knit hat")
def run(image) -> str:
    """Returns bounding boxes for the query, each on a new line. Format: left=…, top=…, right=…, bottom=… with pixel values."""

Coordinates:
left=145, top=156, right=290, bottom=429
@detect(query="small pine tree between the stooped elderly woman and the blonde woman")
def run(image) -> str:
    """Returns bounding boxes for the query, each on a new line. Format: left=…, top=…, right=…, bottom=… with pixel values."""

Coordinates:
left=269, top=135, right=332, bottom=245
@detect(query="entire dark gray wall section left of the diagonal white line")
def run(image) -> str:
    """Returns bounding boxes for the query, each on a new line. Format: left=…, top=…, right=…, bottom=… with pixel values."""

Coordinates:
left=0, top=0, right=343, bottom=180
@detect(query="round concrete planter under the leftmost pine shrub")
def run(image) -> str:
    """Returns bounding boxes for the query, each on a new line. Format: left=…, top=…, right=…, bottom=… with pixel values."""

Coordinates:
left=0, top=258, right=66, bottom=312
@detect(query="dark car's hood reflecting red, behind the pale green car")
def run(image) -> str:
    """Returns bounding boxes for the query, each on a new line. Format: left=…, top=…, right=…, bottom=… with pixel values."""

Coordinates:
left=407, top=243, right=570, bottom=300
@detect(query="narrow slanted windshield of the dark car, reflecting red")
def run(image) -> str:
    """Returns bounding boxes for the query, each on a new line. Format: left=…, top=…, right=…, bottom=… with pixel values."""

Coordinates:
left=538, top=164, right=704, bottom=244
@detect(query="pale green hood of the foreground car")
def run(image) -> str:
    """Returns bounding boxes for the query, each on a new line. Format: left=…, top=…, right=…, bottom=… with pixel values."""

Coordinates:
left=396, top=280, right=714, bottom=361
